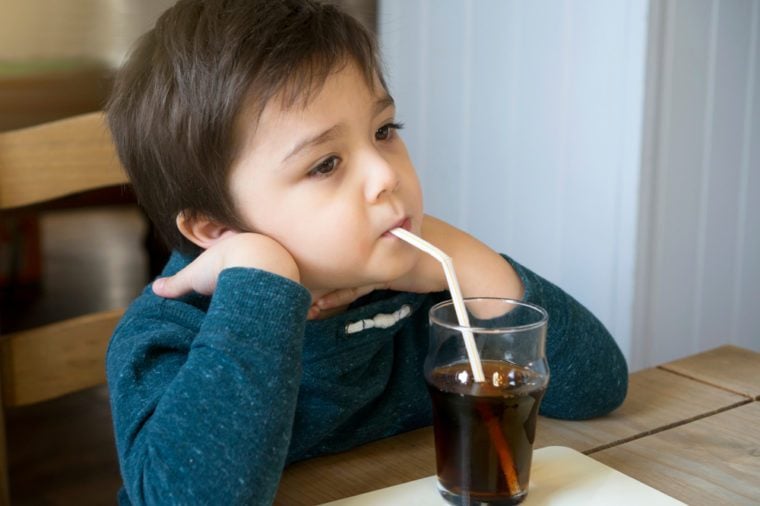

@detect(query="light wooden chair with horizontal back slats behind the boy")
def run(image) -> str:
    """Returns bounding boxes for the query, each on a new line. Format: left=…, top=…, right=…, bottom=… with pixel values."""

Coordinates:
left=0, top=112, right=128, bottom=505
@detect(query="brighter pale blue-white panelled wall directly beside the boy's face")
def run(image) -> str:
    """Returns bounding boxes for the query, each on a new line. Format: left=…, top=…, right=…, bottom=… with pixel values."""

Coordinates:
left=378, top=0, right=647, bottom=364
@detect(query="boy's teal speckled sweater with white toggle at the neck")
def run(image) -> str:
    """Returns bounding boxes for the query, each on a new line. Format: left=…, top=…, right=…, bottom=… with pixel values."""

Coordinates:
left=106, top=253, right=628, bottom=505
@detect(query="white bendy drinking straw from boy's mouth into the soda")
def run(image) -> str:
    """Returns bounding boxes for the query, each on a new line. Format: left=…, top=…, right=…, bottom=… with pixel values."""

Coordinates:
left=391, top=228, right=486, bottom=383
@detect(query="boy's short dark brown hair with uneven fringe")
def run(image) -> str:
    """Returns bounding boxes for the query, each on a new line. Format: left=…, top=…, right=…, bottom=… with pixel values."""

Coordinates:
left=107, top=0, right=385, bottom=252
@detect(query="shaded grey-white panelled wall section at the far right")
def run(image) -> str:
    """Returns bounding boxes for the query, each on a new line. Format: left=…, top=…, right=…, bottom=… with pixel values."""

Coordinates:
left=633, top=0, right=760, bottom=364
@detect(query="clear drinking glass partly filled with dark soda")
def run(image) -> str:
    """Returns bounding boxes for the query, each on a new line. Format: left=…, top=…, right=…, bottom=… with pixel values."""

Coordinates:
left=425, top=298, right=549, bottom=506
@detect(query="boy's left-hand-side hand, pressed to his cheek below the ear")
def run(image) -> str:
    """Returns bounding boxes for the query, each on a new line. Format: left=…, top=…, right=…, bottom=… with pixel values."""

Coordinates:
left=153, top=233, right=300, bottom=298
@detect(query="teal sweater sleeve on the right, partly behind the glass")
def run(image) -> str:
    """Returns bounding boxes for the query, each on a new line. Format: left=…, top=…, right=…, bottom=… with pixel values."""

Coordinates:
left=507, top=258, right=628, bottom=420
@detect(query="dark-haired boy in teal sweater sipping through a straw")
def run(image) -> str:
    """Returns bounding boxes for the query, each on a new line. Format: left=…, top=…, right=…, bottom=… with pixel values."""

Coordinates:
left=107, top=0, right=627, bottom=504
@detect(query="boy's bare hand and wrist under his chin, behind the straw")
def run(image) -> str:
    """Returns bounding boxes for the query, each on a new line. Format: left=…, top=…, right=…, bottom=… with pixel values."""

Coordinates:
left=309, top=216, right=523, bottom=318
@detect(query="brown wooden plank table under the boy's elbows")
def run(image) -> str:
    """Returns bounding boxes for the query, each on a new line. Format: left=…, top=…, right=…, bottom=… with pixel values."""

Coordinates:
left=275, top=346, right=760, bottom=506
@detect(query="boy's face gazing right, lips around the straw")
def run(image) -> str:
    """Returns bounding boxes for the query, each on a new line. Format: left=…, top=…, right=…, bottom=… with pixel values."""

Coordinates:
left=230, top=65, right=423, bottom=290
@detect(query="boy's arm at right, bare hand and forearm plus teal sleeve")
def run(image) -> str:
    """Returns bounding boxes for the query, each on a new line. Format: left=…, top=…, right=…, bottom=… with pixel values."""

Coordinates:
left=317, top=216, right=628, bottom=419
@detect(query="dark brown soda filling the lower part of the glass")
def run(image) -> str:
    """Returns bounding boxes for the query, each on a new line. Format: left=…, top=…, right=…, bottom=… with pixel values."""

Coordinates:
left=428, top=360, right=547, bottom=506
